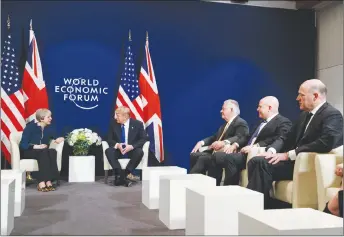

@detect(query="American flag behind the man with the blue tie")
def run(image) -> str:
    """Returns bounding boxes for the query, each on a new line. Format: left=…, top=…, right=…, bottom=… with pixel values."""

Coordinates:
left=115, top=32, right=143, bottom=122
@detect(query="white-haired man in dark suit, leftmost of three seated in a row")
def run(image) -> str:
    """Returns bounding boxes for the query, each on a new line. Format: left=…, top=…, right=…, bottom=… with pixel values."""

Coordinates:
left=190, top=100, right=249, bottom=174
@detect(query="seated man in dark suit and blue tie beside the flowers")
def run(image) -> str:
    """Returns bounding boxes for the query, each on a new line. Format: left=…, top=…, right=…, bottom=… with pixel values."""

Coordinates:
left=105, top=106, right=148, bottom=187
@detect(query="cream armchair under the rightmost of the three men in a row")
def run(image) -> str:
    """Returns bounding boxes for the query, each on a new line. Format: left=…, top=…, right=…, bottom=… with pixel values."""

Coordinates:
left=247, top=146, right=343, bottom=209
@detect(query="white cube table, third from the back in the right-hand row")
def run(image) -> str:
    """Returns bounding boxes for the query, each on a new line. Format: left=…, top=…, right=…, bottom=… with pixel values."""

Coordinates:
left=185, top=186, right=264, bottom=235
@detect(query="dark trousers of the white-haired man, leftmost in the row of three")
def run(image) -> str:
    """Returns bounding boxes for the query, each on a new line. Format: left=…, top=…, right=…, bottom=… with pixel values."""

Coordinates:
left=190, top=150, right=212, bottom=174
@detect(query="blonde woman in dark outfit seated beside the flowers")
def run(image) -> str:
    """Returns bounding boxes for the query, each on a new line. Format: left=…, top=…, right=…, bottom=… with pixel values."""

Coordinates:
left=19, top=109, right=64, bottom=192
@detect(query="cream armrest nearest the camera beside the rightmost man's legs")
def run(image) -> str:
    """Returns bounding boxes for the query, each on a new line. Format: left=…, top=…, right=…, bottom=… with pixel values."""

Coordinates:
left=292, top=152, right=318, bottom=208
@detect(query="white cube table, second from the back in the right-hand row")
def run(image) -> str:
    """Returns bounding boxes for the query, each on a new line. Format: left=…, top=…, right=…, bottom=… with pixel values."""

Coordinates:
left=159, top=174, right=216, bottom=230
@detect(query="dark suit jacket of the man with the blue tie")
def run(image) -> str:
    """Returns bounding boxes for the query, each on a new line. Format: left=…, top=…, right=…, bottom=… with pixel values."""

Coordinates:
left=107, top=118, right=148, bottom=148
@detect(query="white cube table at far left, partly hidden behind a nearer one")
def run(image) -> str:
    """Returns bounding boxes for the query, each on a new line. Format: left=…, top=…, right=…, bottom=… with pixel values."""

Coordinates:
left=1, top=170, right=26, bottom=216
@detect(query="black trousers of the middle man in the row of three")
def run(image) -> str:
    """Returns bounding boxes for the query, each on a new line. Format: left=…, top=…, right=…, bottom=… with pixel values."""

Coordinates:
left=208, top=152, right=247, bottom=186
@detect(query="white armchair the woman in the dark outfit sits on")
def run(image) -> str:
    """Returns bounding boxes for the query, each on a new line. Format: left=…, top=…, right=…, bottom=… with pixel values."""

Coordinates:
left=10, top=132, right=64, bottom=172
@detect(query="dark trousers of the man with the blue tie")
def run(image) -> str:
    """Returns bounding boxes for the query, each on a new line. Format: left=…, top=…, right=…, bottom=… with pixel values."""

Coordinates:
left=105, top=147, right=143, bottom=176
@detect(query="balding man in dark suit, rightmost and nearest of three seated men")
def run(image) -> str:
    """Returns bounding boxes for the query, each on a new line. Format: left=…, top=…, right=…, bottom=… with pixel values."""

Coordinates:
left=247, top=79, right=343, bottom=204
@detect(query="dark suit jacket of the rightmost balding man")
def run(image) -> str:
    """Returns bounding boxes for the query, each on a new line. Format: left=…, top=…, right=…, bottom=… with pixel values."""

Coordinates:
left=283, top=103, right=343, bottom=154
